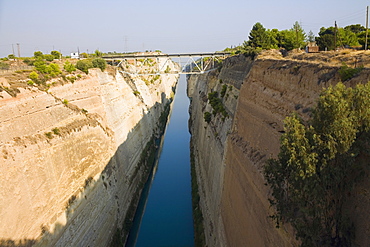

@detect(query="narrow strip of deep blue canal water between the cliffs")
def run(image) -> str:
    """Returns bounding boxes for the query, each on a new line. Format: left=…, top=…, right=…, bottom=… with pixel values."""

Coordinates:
left=127, top=76, right=194, bottom=247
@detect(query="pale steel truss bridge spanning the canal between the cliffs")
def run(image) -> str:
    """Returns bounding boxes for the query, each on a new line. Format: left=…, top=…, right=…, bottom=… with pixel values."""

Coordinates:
left=103, top=52, right=230, bottom=75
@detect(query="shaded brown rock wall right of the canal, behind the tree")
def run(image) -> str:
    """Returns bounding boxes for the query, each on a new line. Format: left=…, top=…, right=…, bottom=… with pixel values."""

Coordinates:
left=188, top=51, right=370, bottom=246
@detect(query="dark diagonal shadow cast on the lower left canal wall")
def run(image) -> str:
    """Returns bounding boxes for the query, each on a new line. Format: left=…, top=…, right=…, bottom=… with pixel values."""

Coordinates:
left=0, top=88, right=175, bottom=247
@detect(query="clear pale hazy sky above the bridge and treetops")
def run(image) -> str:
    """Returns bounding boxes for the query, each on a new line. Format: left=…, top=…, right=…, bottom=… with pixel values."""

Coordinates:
left=0, top=0, right=370, bottom=57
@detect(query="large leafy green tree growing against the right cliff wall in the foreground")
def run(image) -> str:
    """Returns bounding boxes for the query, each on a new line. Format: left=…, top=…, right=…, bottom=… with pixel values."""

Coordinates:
left=264, top=82, right=370, bottom=246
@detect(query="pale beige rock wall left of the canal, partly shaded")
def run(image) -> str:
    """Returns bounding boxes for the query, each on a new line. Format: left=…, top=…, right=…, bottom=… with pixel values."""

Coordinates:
left=0, top=64, right=178, bottom=246
